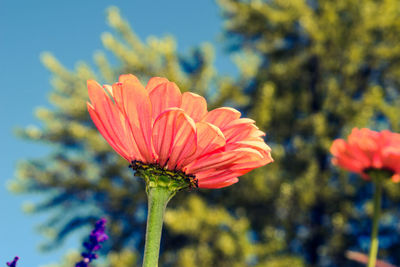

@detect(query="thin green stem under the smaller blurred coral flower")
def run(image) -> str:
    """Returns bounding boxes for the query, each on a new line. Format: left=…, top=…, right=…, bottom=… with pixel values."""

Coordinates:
left=368, top=178, right=382, bottom=267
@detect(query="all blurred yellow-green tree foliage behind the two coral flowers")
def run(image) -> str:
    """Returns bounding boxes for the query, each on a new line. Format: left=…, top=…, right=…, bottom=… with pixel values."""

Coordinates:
left=12, top=0, right=400, bottom=267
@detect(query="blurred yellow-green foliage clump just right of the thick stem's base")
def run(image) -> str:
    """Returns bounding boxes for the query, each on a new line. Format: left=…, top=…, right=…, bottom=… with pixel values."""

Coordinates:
left=163, top=194, right=303, bottom=267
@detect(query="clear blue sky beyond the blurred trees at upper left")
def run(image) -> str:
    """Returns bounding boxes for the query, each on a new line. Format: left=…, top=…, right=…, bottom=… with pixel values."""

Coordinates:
left=0, top=0, right=234, bottom=267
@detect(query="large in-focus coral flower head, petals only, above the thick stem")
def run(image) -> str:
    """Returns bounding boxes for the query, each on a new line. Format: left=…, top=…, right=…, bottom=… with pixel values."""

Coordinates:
left=88, top=74, right=273, bottom=188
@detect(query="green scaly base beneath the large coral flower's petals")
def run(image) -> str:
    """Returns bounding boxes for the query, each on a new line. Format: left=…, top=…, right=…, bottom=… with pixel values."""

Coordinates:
left=129, top=160, right=198, bottom=192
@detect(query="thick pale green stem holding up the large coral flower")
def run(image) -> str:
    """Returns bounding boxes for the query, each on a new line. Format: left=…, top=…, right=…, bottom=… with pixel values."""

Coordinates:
left=143, top=187, right=175, bottom=267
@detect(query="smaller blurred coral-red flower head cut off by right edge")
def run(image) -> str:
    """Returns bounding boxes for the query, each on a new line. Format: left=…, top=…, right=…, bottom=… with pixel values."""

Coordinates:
left=331, top=128, right=400, bottom=182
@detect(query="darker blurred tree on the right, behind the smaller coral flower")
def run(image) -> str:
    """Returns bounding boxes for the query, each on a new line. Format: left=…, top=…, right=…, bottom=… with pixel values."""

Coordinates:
left=219, top=0, right=400, bottom=266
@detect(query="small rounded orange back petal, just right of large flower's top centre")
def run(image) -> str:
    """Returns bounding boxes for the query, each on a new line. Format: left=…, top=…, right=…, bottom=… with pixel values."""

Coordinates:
left=181, top=92, right=207, bottom=122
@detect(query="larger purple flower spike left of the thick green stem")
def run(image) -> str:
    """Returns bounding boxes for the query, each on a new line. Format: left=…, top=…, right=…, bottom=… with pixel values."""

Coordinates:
left=75, top=218, right=108, bottom=267
